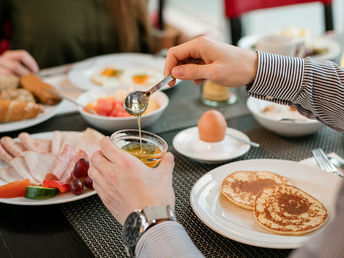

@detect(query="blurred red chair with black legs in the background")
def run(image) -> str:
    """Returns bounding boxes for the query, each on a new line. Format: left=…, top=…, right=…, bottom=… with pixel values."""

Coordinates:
left=224, top=0, right=333, bottom=45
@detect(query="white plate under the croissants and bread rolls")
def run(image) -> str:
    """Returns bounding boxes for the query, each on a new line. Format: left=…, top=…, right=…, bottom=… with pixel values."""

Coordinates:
left=0, top=101, right=62, bottom=133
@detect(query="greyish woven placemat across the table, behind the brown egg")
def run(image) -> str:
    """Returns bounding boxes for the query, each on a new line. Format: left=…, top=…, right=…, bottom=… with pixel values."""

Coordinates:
left=145, top=81, right=250, bottom=133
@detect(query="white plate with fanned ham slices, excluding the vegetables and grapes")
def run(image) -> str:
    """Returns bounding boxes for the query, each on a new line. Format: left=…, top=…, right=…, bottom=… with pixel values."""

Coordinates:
left=0, top=128, right=103, bottom=206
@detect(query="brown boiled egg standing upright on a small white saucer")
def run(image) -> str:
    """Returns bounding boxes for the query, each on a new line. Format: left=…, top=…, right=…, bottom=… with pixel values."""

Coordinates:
left=198, top=110, right=227, bottom=142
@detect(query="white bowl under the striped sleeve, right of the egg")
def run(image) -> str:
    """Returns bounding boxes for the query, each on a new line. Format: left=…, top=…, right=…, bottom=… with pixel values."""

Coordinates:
left=247, top=97, right=324, bottom=137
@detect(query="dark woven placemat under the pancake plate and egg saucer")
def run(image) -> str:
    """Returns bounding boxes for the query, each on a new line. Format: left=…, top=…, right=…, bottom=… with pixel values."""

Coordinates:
left=61, top=127, right=344, bottom=257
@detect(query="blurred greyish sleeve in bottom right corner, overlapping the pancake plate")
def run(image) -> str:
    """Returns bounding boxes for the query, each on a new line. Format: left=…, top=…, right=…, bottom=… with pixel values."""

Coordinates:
left=291, top=181, right=344, bottom=258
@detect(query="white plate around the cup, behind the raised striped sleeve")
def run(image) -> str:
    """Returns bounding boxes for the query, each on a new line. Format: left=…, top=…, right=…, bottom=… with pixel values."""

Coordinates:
left=238, top=35, right=341, bottom=60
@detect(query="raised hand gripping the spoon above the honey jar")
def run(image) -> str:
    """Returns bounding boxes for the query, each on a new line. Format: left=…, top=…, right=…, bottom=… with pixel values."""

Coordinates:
left=164, top=36, right=258, bottom=87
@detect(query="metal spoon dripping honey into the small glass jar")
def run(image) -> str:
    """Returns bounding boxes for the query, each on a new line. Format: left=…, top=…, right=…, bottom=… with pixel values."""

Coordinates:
left=124, top=75, right=174, bottom=116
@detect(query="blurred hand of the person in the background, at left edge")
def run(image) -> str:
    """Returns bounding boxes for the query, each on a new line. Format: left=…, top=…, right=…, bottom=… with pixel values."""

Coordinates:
left=0, top=50, right=39, bottom=76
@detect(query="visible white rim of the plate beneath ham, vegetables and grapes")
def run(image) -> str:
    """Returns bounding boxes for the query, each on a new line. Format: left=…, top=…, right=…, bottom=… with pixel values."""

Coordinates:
left=0, top=132, right=96, bottom=206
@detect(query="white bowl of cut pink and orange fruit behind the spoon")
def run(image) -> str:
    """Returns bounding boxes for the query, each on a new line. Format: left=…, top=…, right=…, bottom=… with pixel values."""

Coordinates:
left=77, top=87, right=168, bottom=131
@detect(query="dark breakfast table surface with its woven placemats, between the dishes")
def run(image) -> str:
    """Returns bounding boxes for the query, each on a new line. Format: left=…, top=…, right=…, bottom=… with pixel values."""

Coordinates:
left=0, top=34, right=344, bottom=258
